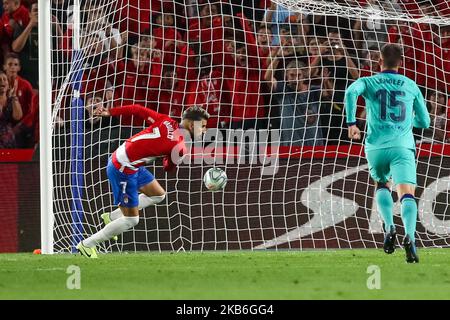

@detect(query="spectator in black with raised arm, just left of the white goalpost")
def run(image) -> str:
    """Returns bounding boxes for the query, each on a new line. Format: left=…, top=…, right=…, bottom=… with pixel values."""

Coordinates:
left=12, top=2, right=39, bottom=89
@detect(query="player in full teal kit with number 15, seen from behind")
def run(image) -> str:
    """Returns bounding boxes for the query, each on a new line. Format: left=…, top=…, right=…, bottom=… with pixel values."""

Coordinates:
left=345, top=44, right=430, bottom=263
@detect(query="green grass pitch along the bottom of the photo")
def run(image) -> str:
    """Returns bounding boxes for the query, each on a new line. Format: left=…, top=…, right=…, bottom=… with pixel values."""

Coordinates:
left=0, top=249, right=450, bottom=300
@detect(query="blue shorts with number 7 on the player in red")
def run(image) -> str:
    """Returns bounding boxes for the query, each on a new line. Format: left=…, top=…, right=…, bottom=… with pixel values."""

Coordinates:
left=106, top=158, right=155, bottom=208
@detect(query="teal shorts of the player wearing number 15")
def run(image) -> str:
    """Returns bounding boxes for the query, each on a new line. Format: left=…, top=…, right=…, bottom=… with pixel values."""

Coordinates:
left=366, top=147, right=417, bottom=185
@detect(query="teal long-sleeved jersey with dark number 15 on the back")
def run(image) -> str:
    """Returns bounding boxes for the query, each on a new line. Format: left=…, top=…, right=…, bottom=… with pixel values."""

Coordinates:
left=344, top=70, right=430, bottom=151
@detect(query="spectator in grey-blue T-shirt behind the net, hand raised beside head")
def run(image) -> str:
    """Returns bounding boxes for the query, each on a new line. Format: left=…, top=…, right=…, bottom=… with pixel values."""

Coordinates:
left=265, top=59, right=323, bottom=146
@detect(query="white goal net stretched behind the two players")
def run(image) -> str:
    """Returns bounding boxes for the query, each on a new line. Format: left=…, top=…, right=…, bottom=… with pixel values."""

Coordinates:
left=44, top=0, right=450, bottom=252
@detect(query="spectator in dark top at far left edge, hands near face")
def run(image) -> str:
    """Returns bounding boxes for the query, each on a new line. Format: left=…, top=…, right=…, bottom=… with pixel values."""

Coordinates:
left=0, top=71, right=23, bottom=148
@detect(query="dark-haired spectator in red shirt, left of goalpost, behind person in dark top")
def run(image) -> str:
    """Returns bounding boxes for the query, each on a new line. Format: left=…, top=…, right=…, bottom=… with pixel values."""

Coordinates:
left=3, top=53, right=33, bottom=123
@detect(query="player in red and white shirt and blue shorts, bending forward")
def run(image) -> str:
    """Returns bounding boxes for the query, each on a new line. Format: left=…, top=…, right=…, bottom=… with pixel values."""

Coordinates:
left=77, top=105, right=209, bottom=258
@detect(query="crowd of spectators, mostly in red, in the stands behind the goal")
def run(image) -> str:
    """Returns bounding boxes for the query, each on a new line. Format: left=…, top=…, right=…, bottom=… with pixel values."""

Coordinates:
left=0, top=0, right=450, bottom=148
